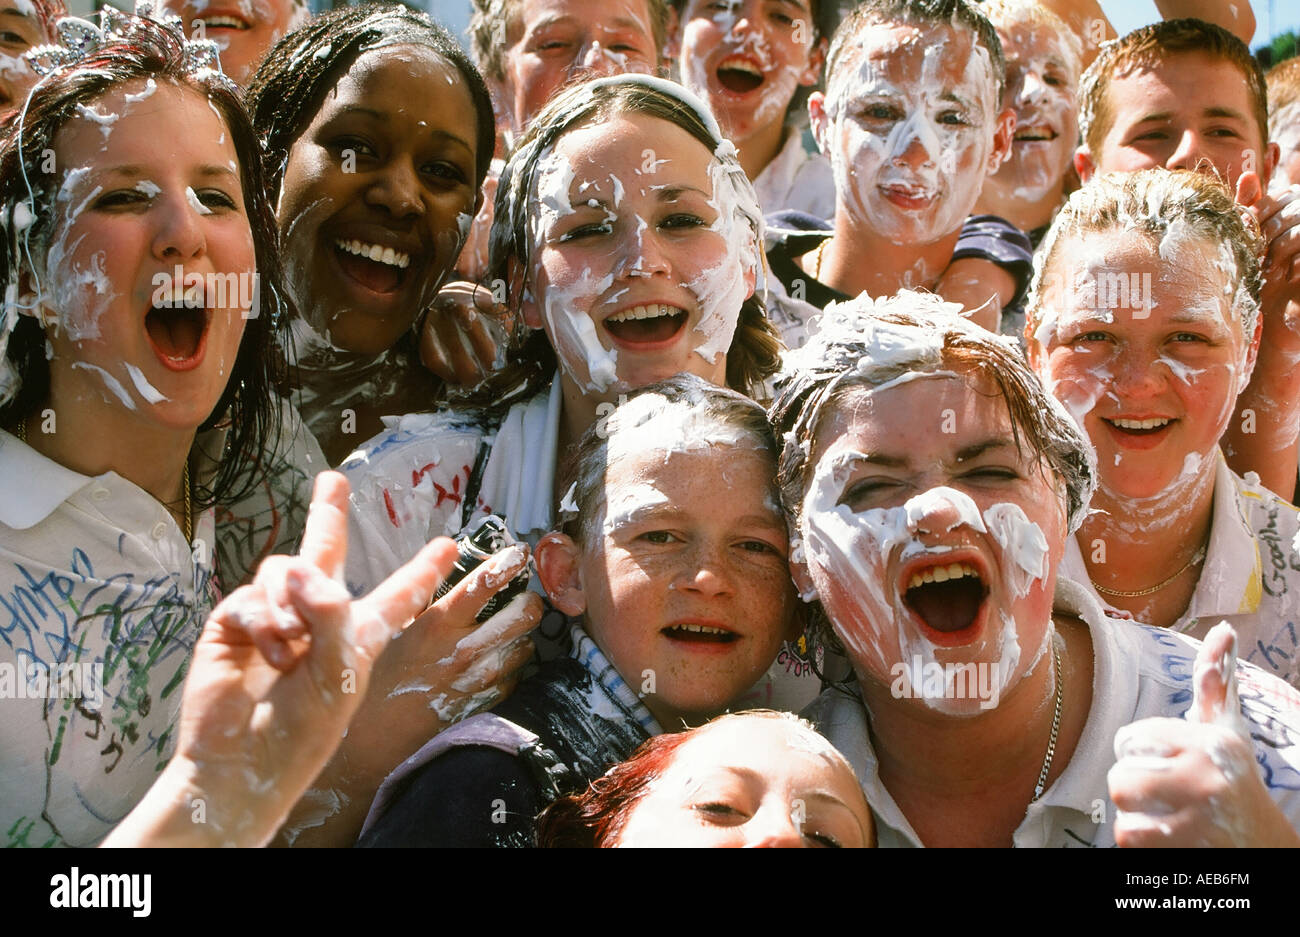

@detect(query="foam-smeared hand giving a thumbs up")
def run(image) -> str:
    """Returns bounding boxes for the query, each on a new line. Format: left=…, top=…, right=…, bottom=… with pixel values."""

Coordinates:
left=1106, top=621, right=1300, bottom=847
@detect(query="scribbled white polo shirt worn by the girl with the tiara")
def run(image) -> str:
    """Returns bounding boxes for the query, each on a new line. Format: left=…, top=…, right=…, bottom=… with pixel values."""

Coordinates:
left=0, top=431, right=217, bottom=846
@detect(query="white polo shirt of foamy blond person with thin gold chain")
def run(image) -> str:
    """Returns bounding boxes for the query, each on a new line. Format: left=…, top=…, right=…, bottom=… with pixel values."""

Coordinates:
left=1060, top=454, right=1300, bottom=686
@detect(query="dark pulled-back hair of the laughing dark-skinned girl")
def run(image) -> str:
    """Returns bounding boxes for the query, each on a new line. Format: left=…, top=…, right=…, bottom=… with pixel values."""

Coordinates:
left=247, top=4, right=497, bottom=200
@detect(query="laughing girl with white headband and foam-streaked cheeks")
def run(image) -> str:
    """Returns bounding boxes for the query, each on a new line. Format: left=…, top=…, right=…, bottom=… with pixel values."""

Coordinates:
left=342, top=75, right=779, bottom=590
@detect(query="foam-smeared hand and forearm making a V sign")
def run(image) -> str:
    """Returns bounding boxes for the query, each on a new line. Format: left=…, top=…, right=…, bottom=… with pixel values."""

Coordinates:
left=105, top=472, right=456, bottom=846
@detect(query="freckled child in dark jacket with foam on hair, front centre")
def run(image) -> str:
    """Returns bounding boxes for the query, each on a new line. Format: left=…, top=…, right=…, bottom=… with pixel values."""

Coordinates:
left=363, top=374, right=796, bottom=846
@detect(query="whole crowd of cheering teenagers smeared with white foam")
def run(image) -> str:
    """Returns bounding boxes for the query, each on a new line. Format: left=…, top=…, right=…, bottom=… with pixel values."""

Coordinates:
left=0, top=0, right=1300, bottom=847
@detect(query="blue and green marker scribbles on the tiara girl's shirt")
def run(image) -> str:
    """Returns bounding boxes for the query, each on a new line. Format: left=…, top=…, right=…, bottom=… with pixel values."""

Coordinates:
left=0, top=548, right=208, bottom=775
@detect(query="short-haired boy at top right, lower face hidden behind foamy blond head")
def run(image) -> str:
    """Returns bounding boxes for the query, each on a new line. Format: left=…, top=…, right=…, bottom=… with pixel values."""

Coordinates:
left=1075, top=19, right=1300, bottom=499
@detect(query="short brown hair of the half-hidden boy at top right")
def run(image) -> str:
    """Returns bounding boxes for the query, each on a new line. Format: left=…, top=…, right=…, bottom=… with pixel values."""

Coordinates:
left=1079, top=19, right=1269, bottom=159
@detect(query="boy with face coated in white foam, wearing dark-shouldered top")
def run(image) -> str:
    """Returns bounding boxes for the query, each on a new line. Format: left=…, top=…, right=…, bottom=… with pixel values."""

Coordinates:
left=768, top=0, right=1030, bottom=348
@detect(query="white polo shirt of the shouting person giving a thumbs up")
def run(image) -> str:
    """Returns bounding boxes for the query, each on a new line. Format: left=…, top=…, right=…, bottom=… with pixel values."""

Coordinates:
left=805, top=580, right=1300, bottom=847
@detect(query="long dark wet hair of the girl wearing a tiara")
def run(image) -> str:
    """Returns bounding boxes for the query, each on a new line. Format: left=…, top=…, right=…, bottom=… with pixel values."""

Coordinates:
left=0, top=14, right=291, bottom=507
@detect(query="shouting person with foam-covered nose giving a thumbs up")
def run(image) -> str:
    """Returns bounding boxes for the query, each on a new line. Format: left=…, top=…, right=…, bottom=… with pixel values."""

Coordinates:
left=771, top=292, right=1300, bottom=847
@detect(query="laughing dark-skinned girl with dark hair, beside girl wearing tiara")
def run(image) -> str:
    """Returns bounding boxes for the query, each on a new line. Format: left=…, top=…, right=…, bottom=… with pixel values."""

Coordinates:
left=248, top=6, right=493, bottom=464
